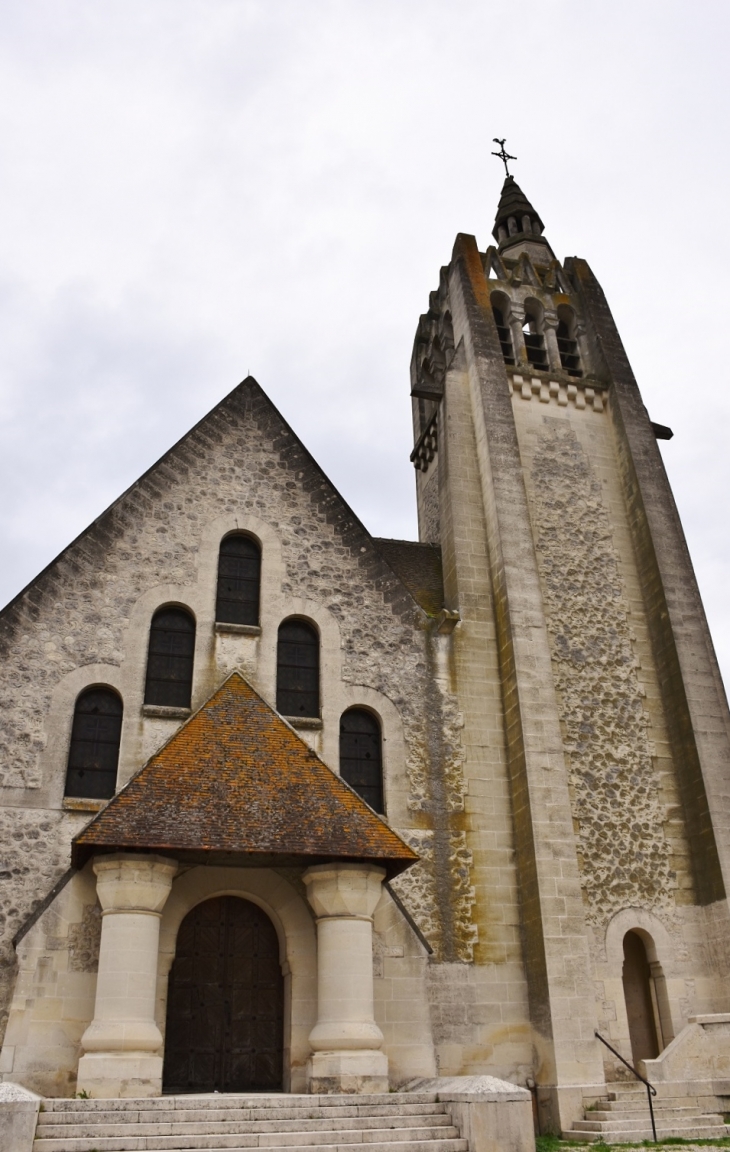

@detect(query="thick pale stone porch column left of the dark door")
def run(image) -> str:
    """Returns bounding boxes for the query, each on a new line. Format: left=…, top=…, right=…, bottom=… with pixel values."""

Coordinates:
left=78, top=854, right=177, bottom=1099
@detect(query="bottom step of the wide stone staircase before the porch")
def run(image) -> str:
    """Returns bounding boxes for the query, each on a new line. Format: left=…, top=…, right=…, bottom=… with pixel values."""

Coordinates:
left=33, top=1129, right=469, bottom=1152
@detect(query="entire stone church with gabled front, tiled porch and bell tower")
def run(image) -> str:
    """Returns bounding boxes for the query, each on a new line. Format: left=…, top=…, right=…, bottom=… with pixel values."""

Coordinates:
left=0, top=177, right=730, bottom=1146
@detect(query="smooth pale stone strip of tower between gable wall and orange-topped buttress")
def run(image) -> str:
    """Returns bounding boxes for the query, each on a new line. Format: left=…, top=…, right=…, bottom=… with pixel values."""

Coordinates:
left=421, top=347, right=532, bottom=1082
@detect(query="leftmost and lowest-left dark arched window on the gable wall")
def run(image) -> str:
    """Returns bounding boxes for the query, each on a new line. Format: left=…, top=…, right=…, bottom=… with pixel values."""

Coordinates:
left=66, top=688, right=123, bottom=799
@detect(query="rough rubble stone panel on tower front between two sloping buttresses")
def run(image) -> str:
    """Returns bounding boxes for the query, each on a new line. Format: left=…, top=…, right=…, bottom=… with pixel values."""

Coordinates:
left=515, top=396, right=677, bottom=927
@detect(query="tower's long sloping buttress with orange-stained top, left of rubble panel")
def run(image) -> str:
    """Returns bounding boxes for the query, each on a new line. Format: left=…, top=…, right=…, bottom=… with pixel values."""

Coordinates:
left=450, top=236, right=602, bottom=1124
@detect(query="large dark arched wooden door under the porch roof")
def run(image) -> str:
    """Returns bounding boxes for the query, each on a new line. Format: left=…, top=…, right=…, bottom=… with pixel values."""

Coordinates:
left=162, top=896, right=284, bottom=1092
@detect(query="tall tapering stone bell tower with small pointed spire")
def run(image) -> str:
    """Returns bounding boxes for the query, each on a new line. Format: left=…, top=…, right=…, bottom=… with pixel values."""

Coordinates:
left=411, top=177, right=730, bottom=1131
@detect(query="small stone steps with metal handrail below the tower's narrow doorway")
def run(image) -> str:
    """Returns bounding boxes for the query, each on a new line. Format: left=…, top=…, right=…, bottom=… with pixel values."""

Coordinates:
left=563, top=1084, right=730, bottom=1144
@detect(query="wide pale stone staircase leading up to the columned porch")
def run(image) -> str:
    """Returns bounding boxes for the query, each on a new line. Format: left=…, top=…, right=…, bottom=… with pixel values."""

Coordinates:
left=33, top=1093, right=465, bottom=1152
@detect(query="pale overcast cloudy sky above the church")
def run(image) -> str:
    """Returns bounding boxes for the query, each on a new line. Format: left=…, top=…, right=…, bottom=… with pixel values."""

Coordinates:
left=0, top=0, right=730, bottom=682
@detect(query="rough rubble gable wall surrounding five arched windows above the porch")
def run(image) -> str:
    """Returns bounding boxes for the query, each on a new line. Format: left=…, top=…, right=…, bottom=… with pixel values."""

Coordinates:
left=0, top=382, right=469, bottom=1076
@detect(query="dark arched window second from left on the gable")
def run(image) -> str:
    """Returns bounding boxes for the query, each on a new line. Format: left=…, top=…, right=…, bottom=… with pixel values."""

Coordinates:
left=144, top=608, right=196, bottom=708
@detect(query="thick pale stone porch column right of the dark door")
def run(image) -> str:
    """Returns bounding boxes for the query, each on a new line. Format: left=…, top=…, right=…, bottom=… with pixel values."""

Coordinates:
left=304, top=864, right=388, bottom=1092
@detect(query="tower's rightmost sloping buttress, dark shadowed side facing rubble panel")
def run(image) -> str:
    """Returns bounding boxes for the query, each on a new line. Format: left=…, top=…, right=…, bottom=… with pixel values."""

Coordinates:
left=566, top=259, right=730, bottom=905
